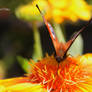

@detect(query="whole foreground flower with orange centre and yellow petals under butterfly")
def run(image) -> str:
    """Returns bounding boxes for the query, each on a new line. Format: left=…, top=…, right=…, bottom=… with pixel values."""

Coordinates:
left=0, top=53, right=92, bottom=92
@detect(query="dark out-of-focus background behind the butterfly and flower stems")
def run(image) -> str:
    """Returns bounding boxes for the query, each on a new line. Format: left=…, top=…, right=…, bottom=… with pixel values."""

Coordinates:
left=0, top=0, right=92, bottom=78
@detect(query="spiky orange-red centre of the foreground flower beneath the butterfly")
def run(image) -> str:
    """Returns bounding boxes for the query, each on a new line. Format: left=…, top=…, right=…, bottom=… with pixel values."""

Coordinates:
left=29, top=56, right=92, bottom=92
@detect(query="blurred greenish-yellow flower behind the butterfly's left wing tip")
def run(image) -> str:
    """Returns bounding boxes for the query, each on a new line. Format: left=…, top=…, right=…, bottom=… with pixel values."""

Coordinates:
left=16, top=0, right=47, bottom=21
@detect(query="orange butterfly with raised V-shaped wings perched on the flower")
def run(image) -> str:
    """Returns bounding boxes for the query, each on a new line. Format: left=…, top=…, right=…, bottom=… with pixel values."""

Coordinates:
left=36, top=5, right=92, bottom=62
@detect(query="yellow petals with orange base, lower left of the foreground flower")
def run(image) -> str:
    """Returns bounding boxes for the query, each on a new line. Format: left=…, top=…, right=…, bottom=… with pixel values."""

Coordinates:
left=0, top=77, right=47, bottom=92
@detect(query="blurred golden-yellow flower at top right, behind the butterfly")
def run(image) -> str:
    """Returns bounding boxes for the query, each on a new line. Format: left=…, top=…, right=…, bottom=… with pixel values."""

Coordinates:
left=46, top=0, right=91, bottom=23
